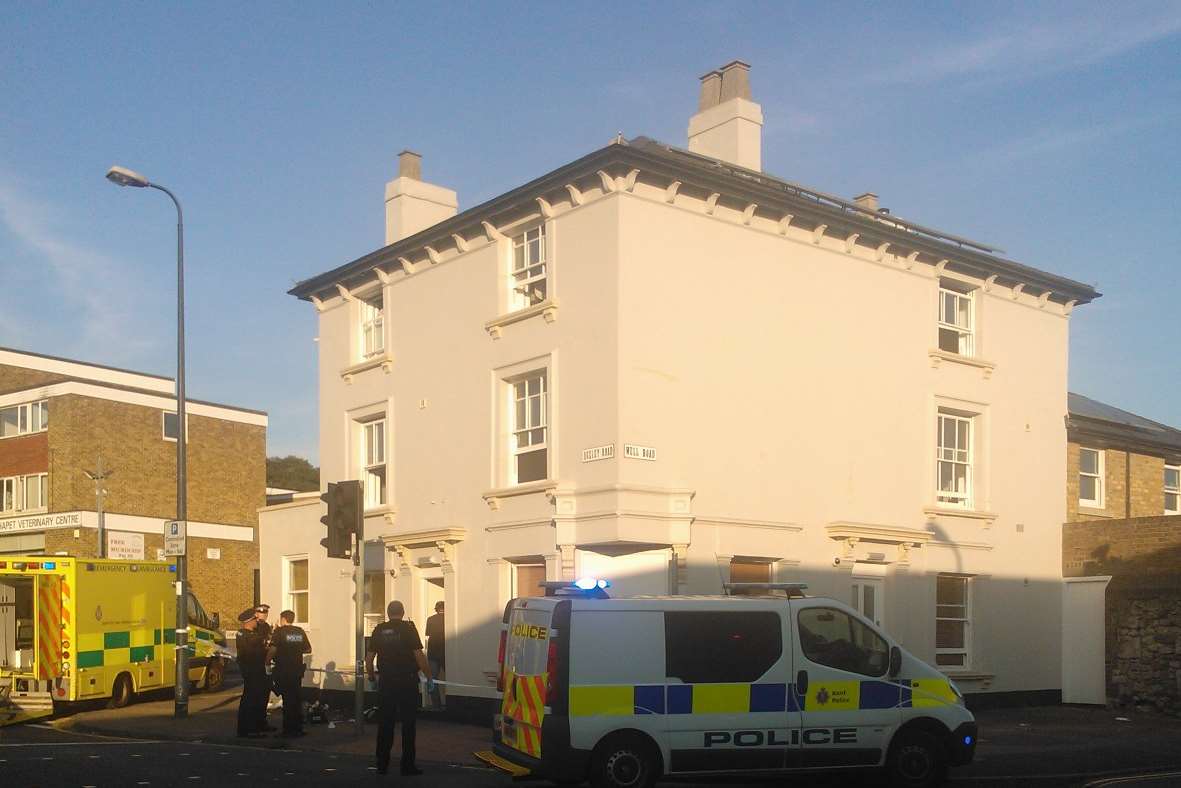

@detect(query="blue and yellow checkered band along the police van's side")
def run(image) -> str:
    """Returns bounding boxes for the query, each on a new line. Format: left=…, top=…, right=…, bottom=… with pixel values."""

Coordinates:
left=569, top=678, right=955, bottom=717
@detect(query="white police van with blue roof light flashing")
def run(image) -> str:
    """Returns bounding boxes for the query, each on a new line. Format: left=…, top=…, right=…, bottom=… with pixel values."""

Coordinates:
left=477, top=579, right=977, bottom=788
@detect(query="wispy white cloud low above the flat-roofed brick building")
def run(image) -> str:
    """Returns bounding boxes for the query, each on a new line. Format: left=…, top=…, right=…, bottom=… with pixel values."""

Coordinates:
left=0, top=176, right=156, bottom=362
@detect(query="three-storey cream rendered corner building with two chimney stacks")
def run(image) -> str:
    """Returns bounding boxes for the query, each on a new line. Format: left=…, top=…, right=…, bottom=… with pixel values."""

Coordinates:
left=261, top=63, right=1098, bottom=713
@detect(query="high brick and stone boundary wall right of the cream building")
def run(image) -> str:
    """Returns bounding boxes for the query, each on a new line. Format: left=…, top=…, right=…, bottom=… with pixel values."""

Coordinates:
left=1062, top=515, right=1181, bottom=715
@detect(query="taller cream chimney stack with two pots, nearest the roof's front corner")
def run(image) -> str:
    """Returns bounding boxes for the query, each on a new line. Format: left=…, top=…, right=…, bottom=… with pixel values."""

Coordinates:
left=689, top=60, right=763, bottom=170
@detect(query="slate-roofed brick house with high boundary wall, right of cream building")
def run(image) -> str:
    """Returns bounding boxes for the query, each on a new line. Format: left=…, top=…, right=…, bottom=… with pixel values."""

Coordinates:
left=1062, top=393, right=1181, bottom=714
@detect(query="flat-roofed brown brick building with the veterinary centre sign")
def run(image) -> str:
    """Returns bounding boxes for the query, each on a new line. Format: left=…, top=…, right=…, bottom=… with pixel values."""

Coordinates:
left=0, top=349, right=267, bottom=620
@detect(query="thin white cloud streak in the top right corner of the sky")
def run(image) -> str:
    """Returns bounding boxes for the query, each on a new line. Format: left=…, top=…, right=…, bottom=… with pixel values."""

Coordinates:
left=868, top=4, right=1181, bottom=84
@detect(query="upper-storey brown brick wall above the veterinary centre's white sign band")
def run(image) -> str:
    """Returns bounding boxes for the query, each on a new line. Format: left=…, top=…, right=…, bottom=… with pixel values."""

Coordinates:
left=50, top=395, right=267, bottom=527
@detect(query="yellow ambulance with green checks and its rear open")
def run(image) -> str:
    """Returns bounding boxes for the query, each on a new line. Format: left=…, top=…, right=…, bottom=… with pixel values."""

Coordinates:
left=0, top=555, right=227, bottom=725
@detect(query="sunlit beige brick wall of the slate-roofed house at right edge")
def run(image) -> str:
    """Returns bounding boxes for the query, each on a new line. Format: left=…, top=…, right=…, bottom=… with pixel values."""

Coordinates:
left=1066, top=441, right=1164, bottom=522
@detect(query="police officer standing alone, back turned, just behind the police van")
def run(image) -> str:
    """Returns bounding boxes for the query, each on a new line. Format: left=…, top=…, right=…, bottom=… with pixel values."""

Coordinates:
left=365, top=600, right=430, bottom=776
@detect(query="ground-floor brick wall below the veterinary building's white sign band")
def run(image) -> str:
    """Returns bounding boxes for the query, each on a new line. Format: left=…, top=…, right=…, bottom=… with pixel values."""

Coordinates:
left=45, top=528, right=259, bottom=630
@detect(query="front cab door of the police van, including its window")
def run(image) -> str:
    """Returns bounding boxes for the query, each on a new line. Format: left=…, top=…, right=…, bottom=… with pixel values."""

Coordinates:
left=791, top=599, right=902, bottom=768
